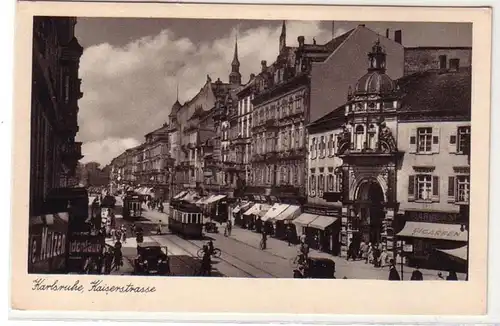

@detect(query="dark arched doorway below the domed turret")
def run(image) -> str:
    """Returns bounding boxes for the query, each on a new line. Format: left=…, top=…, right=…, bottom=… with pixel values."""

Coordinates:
left=357, top=179, right=385, bottom=244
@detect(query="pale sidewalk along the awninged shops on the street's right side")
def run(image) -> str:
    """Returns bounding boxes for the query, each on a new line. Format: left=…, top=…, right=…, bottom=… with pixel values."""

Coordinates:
left=223, top=226, right=465, bottom=280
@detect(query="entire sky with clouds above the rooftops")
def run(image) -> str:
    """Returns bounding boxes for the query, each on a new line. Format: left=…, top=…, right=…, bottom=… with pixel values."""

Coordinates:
left=75, top=18, right=472, bottom=165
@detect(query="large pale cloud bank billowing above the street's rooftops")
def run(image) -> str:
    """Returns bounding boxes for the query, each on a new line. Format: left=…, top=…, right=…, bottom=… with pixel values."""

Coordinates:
left=78, top=21, right=334, bottom=164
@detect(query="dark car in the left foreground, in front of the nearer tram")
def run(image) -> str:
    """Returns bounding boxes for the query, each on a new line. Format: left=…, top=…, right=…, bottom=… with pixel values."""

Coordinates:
left=134, top=242, right=170, bottom=275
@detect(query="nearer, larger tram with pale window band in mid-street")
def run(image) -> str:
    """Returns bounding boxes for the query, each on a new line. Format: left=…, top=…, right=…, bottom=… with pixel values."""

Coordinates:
left=168, top=199, right=203, bottom=239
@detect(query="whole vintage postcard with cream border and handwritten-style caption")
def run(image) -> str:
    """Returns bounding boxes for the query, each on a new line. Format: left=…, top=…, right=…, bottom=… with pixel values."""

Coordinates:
left=11, top=2, right=491, bottom=315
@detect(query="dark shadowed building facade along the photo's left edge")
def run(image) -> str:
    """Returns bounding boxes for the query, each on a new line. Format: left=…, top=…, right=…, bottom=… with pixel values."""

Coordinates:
left=30, top=17, right=83, bottom=216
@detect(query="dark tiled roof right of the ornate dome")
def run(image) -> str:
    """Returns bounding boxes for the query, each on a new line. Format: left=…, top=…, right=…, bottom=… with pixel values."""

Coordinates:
left=397, top=68, right=472, bottom=117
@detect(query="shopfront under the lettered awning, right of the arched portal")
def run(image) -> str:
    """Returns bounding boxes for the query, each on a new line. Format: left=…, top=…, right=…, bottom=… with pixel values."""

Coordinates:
left=397, top=221, right=468, bottom=272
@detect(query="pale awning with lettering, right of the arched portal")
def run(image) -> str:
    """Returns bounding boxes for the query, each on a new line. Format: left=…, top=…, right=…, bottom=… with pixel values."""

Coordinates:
left=397, top=222, right=468, bottom=242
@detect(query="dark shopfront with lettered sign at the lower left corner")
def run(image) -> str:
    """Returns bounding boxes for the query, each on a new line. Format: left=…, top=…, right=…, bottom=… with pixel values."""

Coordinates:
left=28, top=212, right=69, bottom=274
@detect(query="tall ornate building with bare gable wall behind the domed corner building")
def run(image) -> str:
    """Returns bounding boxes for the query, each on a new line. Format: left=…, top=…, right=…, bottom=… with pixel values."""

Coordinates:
left=251, top=23, right=403, bottom=204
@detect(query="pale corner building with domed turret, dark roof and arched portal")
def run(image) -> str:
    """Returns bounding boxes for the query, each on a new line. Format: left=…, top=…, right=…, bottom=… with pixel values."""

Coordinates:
left=308, top=42, right=471, bottom=266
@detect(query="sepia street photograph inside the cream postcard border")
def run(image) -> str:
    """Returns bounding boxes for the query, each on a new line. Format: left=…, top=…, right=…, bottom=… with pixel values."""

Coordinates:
left=26, top=16, right=481, bottom=281
